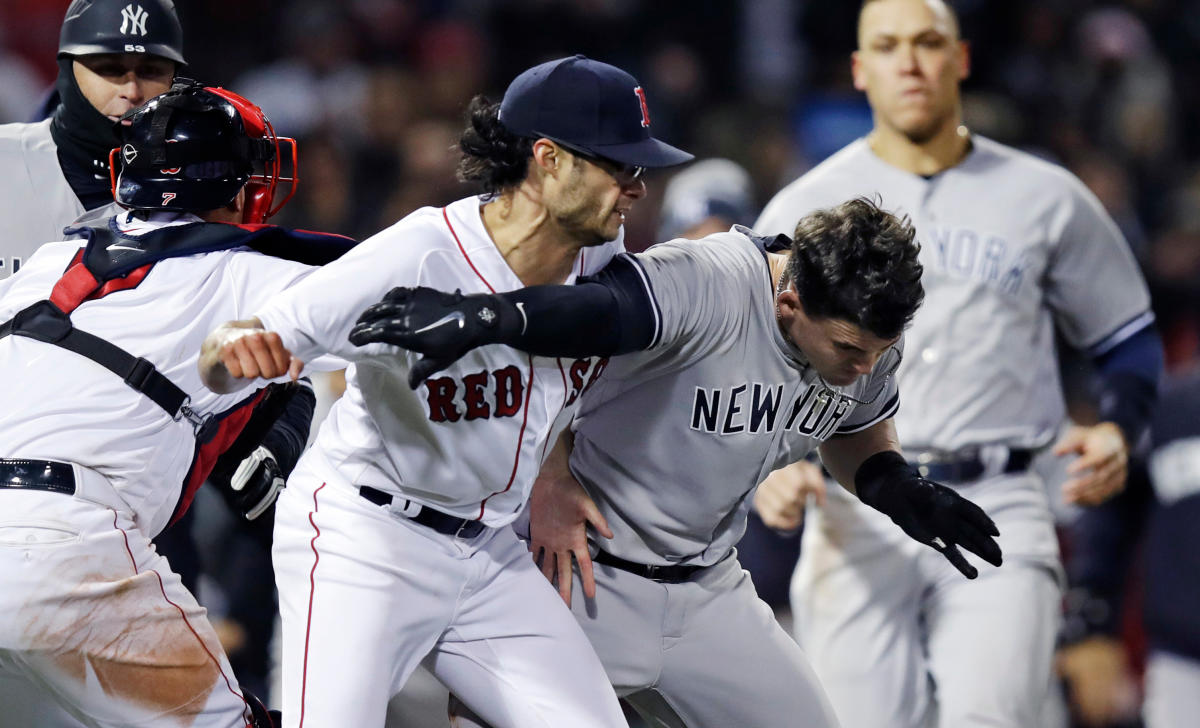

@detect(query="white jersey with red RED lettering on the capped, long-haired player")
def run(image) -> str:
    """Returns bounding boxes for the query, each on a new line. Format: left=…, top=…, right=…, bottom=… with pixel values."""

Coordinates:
left=254, top=197, right=622, bottom=527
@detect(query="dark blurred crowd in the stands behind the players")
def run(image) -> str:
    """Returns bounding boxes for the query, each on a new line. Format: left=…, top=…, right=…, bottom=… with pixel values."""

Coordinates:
left=0, top=0, right=1200, bottom=728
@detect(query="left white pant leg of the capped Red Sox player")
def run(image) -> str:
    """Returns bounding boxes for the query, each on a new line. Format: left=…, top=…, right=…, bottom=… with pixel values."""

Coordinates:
left=272, top=470, right=460, bottom=728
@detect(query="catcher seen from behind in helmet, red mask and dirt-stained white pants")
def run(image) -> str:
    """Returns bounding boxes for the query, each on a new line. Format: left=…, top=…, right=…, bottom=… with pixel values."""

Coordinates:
left=0, top=82, right=347, bottom=728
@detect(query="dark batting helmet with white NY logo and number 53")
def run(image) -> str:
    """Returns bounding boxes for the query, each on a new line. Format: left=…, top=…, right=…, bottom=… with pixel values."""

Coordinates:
left=59, top=0, right=187, bottom=65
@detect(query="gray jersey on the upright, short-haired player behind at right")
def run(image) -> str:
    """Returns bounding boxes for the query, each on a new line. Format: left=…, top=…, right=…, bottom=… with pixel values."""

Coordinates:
left=755, top=136, right=1152, bottom=450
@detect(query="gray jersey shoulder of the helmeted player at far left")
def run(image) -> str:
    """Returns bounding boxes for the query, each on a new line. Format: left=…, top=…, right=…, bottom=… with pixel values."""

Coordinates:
left=0, top=119, right=84, bottom=278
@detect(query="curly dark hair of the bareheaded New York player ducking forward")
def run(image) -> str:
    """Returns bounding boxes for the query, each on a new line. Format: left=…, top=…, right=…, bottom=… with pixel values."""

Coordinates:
left=785, top=197, right=925, bottom=338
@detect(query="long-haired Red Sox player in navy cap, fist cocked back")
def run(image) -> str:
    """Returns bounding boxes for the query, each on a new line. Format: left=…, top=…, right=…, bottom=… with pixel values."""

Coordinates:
left=204, top=55, right=691, bottom=728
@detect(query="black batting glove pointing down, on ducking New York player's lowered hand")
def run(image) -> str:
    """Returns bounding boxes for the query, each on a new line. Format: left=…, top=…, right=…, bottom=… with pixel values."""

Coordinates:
left=854, top=450, right=1003, bottom=579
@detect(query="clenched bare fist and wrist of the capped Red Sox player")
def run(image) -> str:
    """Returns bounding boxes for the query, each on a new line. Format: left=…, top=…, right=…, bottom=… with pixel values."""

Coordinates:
left=199, top=319, right=304, bottom=395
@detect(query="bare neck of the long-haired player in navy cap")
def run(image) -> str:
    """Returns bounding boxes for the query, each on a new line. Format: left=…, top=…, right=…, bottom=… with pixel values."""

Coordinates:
left=480, top=189, right=580, bottom=285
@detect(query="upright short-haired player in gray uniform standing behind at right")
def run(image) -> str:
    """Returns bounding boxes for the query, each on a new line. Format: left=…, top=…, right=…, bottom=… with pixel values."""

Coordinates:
left=755, top=0, right=1162, bottom=728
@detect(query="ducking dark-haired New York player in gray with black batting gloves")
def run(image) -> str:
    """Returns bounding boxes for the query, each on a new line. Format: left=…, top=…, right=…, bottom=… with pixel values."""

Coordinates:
left=352, top=199, right=1001, bottom=728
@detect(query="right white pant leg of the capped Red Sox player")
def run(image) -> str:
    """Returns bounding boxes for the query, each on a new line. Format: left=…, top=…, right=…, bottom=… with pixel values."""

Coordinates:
left=426, top=529, right=628, bottom=728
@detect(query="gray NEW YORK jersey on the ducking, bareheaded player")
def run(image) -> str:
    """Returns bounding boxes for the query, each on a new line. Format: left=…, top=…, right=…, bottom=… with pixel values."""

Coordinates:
left=571, top=228, right=899, bottom=565
